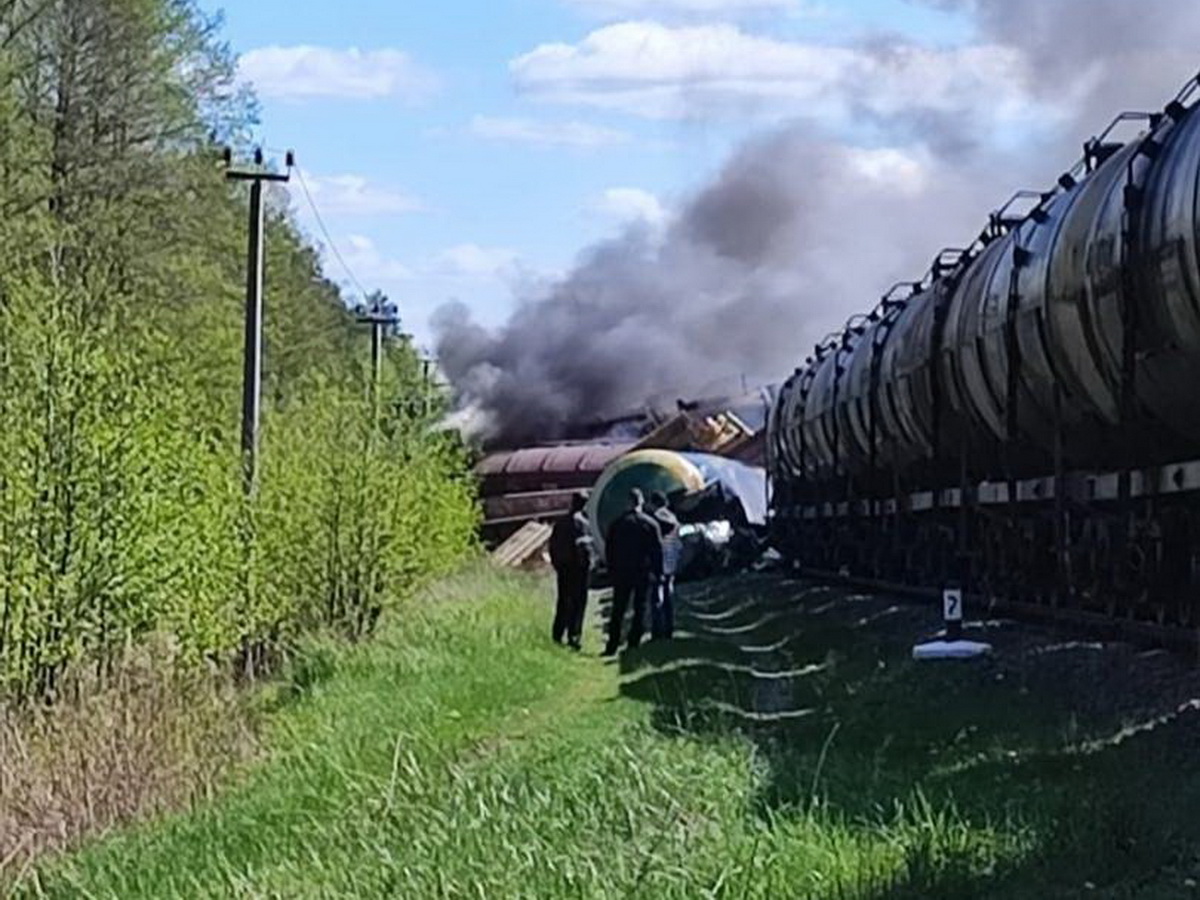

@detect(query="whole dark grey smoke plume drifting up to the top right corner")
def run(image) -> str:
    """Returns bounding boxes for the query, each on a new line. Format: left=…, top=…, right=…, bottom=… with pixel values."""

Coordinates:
left=434, top=0, right=1200, bottom=445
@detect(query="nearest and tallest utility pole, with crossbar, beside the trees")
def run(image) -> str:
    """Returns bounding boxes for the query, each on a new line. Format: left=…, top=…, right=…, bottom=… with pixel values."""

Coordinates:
left=224, top=148, right=295, bottom=496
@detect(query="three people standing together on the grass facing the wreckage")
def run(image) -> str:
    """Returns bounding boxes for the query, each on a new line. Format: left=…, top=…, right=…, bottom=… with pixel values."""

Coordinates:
left=550, top=488, right=682, bottom=656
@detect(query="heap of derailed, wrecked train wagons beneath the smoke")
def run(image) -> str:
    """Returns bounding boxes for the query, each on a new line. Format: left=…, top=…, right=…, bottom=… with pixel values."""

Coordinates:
left=475, top=389, right=773, bottom=580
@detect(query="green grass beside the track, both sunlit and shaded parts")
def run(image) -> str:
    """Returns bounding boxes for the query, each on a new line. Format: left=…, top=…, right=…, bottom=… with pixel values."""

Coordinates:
left=17, top=572, right=1200, bottom=900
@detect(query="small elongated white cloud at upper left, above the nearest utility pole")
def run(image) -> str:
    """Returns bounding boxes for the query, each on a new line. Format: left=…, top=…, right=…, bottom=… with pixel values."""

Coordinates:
left=239, top=44, right=437, bottom=101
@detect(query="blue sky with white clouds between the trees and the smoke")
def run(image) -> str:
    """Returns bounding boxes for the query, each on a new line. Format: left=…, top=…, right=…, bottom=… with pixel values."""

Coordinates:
left=203, top=0, right=970, bottom=346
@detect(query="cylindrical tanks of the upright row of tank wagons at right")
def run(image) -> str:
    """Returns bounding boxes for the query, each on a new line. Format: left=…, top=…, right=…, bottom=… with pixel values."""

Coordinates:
left=768, top=77, right=1200, bottom=493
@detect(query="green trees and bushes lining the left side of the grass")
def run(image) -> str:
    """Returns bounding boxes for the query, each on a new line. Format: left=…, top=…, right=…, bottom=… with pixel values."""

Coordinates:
left=0, top=0, right=476, bottom=701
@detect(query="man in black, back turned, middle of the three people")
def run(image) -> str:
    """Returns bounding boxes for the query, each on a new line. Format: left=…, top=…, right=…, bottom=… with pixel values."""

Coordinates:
left=604, top=487, right=662, bottom=656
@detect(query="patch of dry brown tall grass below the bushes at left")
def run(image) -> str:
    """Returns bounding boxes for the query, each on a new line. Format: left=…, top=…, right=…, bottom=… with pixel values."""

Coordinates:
left=0, top=641, right=256, bottom=883
